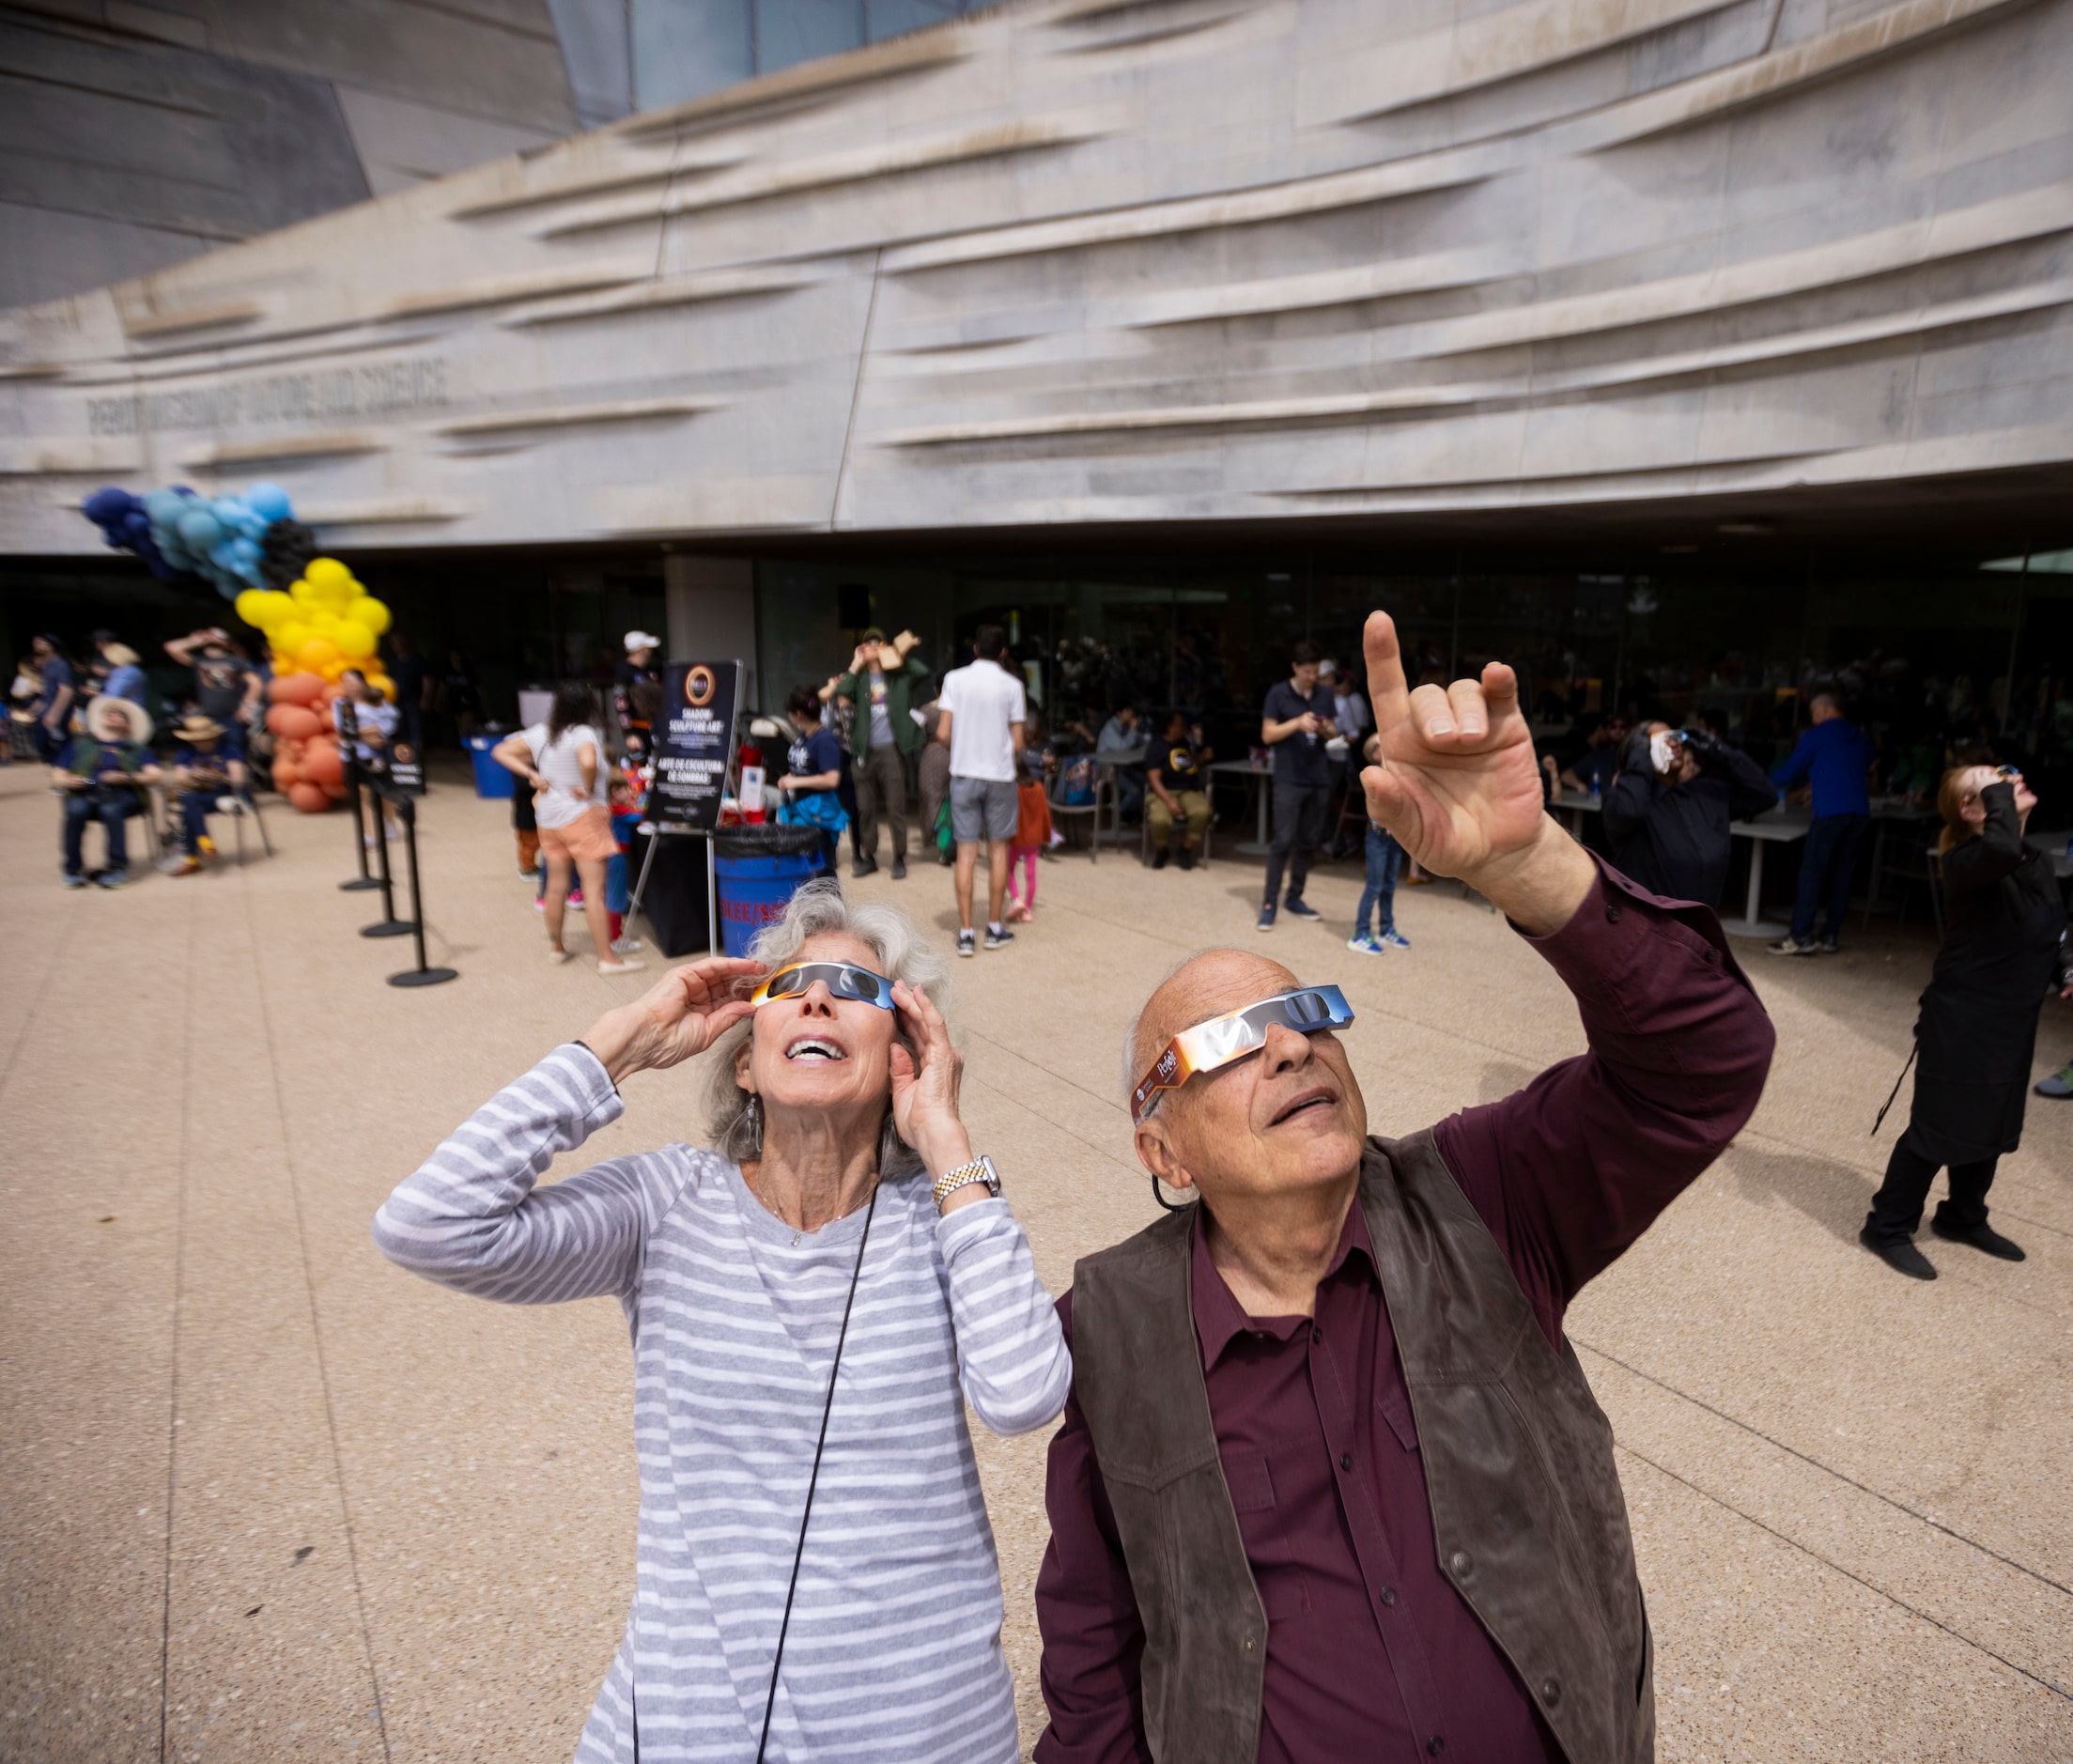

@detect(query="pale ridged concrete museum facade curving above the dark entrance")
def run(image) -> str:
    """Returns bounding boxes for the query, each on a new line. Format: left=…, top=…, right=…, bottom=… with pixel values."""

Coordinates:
left=0, top=0, right=2073, bottom=551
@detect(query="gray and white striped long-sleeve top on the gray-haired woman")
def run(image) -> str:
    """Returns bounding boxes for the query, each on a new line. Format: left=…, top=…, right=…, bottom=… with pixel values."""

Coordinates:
left=375, top=1046, right=1072, bottom=1764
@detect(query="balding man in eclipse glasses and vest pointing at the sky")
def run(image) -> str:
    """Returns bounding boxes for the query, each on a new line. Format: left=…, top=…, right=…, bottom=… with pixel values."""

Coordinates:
left=1037, top=613, right=1772, bottom=1764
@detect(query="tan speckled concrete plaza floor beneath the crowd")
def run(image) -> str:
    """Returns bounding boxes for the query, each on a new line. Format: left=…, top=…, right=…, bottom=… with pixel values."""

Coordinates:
left=0, top=767, right=2073, bottom=1764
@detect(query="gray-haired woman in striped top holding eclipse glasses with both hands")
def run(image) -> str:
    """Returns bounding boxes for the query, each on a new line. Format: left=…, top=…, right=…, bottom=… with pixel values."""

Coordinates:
left=375, top=883, right=1072, bottom=1764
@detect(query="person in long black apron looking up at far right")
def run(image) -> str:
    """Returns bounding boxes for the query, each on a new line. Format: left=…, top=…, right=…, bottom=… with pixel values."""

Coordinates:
left=1857, top=765, right=2073, bottom=1281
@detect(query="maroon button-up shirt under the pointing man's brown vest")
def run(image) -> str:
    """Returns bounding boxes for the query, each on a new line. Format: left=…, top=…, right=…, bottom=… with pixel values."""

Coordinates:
left=1037, top=866, right=1772, bottom=1764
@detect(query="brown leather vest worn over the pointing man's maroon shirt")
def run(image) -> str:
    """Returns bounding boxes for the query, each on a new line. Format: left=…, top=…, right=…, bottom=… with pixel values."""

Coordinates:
left=1072, top=1132, right=1656, bottom=1764
